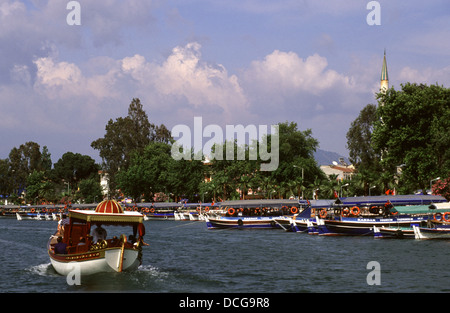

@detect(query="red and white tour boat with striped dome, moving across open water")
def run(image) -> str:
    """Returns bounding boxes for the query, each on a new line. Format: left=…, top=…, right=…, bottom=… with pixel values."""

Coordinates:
left=47, top=200, right=145, bottom=275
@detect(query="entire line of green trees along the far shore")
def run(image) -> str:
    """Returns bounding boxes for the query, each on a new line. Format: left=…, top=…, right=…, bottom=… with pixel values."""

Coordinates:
left=0, top=83, right=450, bottom=203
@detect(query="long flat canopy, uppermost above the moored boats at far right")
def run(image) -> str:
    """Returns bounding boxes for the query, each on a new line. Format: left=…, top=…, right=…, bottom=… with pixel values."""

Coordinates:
left=335, top=195, right=447, bottom=206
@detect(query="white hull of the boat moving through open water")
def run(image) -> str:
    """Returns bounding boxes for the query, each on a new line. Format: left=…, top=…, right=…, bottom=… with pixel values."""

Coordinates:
left=49, top=247, right=141, bottom=276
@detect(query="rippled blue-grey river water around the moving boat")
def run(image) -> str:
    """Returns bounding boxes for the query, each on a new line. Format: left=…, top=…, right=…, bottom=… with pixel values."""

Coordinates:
left=0, top=218, right=450, bottom=294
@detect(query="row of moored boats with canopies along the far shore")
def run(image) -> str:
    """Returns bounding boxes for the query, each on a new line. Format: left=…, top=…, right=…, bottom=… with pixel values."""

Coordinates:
left=0, top=195, right=450, bottom=239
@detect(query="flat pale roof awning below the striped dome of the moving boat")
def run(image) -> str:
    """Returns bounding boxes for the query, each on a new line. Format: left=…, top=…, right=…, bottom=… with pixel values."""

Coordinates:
left=69, top=210, right=144, bottom=224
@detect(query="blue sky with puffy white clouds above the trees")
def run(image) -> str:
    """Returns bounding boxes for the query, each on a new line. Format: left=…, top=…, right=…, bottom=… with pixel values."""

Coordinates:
left=0, top=0, right=450, bottom=162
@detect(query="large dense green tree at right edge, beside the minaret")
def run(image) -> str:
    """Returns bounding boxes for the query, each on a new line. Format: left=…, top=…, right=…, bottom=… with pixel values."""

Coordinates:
left=373, top=83, right=450, bottom=192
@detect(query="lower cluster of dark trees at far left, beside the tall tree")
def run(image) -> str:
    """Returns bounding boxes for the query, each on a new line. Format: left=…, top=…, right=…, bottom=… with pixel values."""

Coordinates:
left=0, top=141, right=102, bottom=204
